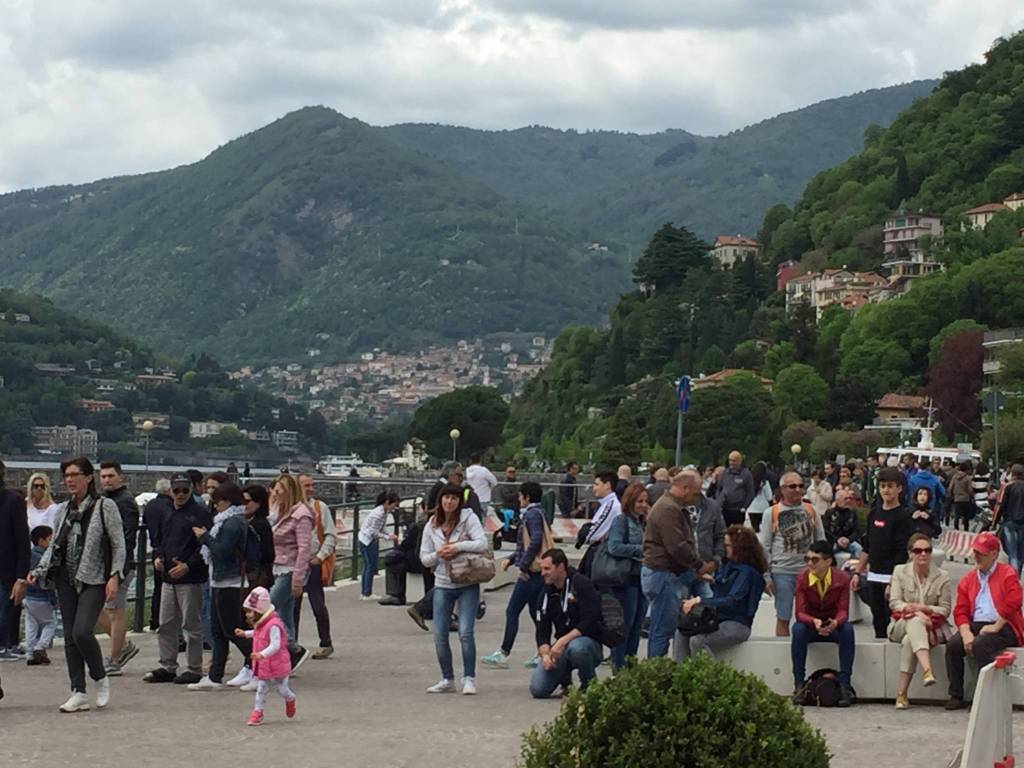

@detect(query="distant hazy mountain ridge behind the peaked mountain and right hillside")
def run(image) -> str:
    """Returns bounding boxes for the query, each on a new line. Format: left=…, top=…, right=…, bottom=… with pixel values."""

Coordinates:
left=384, top=80, right=937, bottom=247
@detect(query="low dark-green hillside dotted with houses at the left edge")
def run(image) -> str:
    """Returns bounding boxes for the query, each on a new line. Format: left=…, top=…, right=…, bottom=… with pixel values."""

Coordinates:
left=0, top=289, right=315, bottom=461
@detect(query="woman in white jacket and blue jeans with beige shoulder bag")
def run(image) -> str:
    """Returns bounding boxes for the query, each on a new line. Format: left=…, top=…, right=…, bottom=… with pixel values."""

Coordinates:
left=420, top=483, right=487, bottom=694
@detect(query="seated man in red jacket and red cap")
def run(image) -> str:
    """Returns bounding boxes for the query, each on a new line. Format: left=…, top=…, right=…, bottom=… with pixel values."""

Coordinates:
left=946, top=532, right=1024, bottom=710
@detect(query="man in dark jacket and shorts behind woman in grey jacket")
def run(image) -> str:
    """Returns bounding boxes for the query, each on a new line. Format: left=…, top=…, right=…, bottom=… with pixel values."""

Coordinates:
left=99, top=462, right=139, bottom=677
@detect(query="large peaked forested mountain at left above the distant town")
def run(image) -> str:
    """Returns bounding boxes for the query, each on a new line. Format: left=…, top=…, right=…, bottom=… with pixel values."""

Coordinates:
left=0, top=108, right=626, bottom=362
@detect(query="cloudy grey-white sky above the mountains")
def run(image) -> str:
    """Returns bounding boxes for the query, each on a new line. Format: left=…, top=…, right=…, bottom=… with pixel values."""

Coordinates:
left=0, top=0, right=1024, bottom=191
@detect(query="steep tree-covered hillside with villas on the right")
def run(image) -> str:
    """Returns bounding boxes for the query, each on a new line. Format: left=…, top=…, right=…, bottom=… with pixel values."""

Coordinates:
left=506, top=33, right=1024, bottom=462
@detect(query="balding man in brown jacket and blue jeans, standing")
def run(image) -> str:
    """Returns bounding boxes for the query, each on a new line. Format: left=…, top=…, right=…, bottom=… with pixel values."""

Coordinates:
left=640, top=470, right=700, bottom=658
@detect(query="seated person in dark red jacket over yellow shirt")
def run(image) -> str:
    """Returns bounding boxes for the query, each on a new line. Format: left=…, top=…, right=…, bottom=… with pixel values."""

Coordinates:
left=790, top=541, right=857, bottom=707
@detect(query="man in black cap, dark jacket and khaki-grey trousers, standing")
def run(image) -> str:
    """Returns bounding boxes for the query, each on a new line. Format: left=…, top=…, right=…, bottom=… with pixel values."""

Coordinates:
left=142, top=473, right=213, bottom=685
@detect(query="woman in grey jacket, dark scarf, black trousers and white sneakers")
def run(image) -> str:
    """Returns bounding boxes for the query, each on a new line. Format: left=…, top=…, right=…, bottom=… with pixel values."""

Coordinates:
left=29, top=457, right=125, bottom=712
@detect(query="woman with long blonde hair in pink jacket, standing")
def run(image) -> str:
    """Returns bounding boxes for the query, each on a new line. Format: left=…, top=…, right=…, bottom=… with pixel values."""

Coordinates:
left=270, top=474, right=314, bottom=671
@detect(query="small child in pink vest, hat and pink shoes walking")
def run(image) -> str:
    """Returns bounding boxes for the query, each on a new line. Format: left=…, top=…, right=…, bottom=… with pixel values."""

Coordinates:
left=234, top=587, right=295, bottom=725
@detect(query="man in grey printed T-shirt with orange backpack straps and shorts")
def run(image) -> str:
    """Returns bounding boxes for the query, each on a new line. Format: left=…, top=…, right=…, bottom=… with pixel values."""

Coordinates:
left=758, top=472, right=825, bottom=637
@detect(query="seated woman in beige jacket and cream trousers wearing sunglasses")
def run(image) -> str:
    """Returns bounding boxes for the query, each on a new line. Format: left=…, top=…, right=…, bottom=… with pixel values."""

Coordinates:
left=889, top=534, right=952, bottom=710
